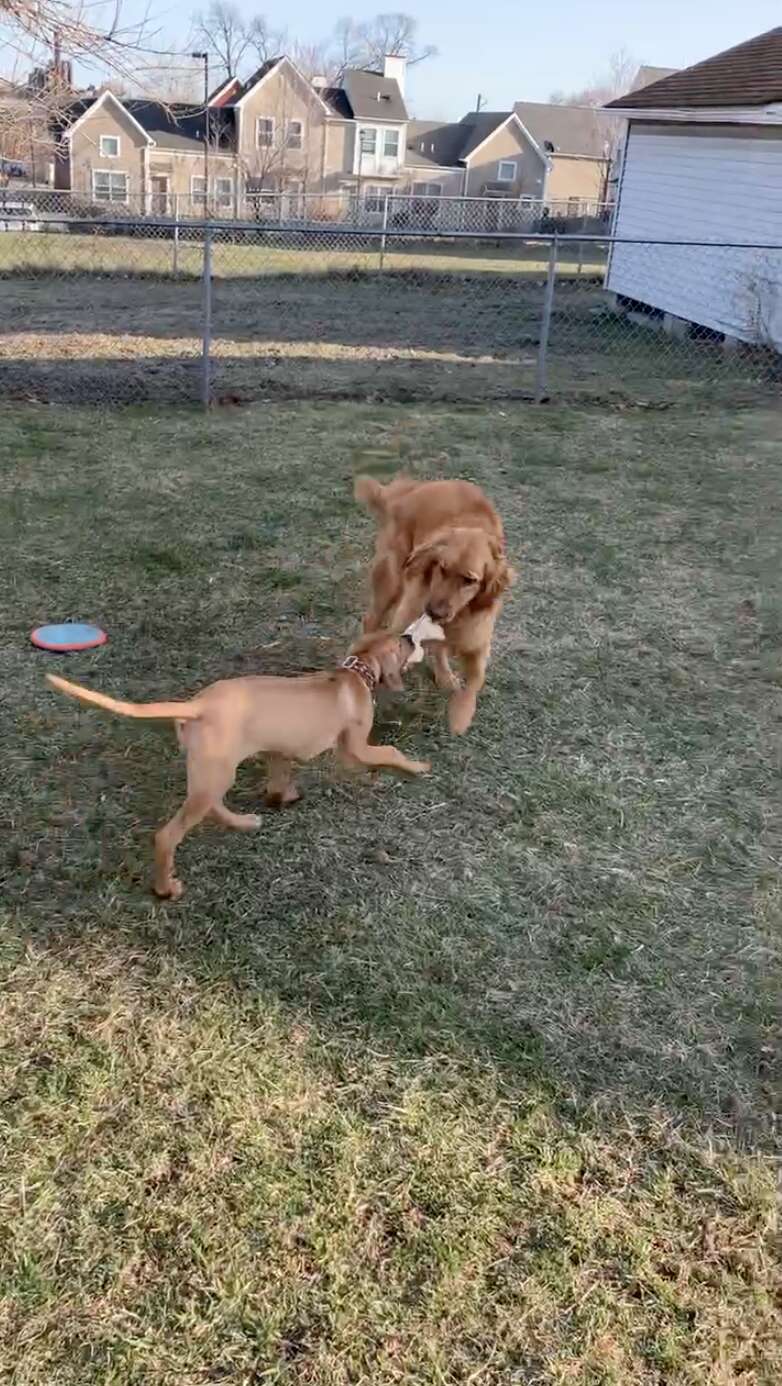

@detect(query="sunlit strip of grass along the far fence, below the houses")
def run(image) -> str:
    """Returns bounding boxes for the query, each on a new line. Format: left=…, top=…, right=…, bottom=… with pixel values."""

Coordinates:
left=0, top=226, right=606, bottom=279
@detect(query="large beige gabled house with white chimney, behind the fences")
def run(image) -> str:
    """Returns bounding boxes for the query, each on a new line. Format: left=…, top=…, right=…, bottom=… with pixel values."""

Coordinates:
left=55, top=57, right=408, bottom=215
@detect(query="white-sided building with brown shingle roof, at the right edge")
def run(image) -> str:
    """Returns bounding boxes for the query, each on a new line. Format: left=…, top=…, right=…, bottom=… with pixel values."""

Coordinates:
left=606, top=28, right=782, bottom=351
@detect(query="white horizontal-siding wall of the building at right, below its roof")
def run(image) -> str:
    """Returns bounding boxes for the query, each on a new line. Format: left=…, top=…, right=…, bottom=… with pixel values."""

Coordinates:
left=606, top=125, right=782, bottom=349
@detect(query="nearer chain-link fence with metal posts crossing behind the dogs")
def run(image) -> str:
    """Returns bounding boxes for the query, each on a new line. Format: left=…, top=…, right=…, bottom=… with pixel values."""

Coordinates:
left=0, top=210, right=782, bottom=405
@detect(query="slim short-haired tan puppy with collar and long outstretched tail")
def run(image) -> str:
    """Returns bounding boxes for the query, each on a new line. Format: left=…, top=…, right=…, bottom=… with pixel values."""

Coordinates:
left=46, top=633, right=430, bottom=900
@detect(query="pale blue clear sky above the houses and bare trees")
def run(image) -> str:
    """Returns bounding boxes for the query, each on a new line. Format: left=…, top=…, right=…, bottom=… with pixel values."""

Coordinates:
left=18, top=0, right=782, bottom=119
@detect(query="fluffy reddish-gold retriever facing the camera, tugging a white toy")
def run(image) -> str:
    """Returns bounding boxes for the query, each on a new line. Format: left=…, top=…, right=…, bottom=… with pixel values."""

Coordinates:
left=355, top=477, right=514, bottom=736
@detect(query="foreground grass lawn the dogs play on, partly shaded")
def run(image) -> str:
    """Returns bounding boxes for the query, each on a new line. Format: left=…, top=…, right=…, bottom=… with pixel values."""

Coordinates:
left=0, top=402, right=782, bottom=1386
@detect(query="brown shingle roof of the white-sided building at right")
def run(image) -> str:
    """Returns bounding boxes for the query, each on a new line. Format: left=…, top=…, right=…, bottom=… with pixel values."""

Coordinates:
left=609, top=26, right=782, bottom=111
